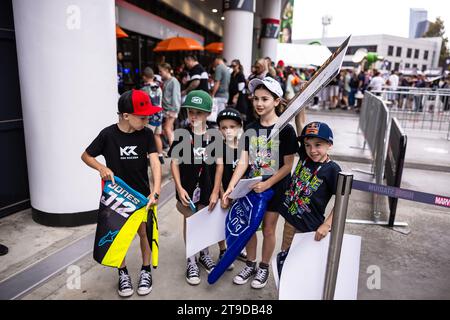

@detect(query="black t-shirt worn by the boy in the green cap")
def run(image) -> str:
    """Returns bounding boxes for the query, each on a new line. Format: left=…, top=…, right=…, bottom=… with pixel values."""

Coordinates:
left=168, top=129, right=216, bottom=206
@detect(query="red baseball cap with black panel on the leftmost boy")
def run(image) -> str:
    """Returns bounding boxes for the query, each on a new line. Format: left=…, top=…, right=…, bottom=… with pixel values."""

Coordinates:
left=118, top=89, right=162, bottom=116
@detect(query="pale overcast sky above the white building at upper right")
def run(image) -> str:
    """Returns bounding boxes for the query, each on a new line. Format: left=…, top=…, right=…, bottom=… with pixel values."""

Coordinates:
left=292, top=0, right=450, bottom=40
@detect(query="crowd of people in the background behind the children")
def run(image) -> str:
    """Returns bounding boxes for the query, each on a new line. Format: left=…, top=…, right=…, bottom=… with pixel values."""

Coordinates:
left=117, top=53, right=450, bottom=163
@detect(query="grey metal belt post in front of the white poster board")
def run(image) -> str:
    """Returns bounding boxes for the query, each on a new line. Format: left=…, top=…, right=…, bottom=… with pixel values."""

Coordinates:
left=322, top=172, right=353, bottom=300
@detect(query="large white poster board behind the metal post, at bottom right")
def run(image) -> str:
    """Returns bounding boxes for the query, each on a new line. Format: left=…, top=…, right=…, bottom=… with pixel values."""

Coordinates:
left=279, top=232, right=361, bottom=300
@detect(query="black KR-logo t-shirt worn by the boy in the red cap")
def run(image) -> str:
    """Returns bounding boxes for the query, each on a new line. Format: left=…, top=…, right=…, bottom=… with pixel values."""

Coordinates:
left=86, top=124, right=156, bottom=197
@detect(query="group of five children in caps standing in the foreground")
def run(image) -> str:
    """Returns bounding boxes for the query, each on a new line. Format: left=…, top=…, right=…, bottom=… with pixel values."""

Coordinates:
left=82, top=77, right=340, bottom=296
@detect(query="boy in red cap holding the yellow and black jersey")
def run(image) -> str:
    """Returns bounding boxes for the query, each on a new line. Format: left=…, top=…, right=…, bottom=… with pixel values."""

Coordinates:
left=81, top=90, right=161, bottom=297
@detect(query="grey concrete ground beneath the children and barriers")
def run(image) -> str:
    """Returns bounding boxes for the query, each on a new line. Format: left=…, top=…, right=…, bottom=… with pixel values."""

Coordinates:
left=0, top=112, right=450, bottom=300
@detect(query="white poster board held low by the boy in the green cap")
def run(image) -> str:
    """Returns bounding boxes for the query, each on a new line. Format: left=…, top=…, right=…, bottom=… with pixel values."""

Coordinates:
left=186, top=201, right=228, bottom=258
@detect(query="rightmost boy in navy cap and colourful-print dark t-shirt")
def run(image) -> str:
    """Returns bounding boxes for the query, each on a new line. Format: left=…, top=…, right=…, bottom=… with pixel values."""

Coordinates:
left=277, top=122, right=341, bottom=275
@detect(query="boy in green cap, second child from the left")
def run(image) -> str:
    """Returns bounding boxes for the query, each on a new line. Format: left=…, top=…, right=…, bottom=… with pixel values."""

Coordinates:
left=169, top=90, right=223, bottom=285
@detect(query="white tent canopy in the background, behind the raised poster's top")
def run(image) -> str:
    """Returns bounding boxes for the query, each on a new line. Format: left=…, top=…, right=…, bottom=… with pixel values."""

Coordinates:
left=275, top=43, right=331, bottom=68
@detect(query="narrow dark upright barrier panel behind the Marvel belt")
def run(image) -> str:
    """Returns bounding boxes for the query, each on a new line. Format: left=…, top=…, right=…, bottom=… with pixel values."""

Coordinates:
left=384, top=118, right=407, bottom=228
